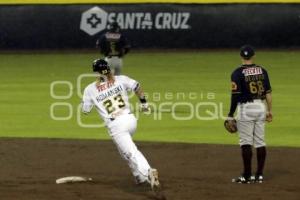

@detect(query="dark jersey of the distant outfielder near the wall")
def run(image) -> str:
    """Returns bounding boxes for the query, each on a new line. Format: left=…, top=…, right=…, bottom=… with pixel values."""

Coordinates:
left=97, top=32, right=130, bottom=57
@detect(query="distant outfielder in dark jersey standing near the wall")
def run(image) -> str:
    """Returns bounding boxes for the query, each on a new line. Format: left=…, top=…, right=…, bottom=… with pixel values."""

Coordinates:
left=96, top=22, right=130, bottom=75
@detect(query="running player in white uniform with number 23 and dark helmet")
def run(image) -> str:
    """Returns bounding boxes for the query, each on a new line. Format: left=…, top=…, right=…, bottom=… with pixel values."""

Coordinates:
left=82, top=59, right=160, bottom=191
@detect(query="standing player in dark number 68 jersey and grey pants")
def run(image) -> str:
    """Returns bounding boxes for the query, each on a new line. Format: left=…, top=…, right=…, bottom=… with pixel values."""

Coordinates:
left=227, top=45, right=273, bottom=183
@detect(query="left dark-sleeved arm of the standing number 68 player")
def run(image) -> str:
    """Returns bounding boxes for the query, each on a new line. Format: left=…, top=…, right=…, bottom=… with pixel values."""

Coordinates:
left=228, top=71, right=241, bottom=119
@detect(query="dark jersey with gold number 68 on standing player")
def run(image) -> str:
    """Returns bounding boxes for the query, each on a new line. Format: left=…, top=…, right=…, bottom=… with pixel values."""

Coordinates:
left=231, top=64, right=272, bottom=103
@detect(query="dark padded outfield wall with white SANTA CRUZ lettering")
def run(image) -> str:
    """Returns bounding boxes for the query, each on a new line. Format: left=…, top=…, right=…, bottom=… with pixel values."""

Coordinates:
left=0, top=3, right=300, bottom=49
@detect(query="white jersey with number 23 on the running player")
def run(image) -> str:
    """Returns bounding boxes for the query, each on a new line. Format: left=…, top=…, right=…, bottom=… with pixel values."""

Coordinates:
left=82, top=75, right=139, bottom=122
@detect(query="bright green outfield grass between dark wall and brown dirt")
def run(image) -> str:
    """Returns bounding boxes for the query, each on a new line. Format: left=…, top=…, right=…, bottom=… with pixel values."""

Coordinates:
left=0, top=51, right=300, bottom=147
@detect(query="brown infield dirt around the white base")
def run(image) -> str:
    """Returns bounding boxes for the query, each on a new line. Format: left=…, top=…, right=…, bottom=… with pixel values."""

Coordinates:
left=0, top=138, right=300, bottom=200
